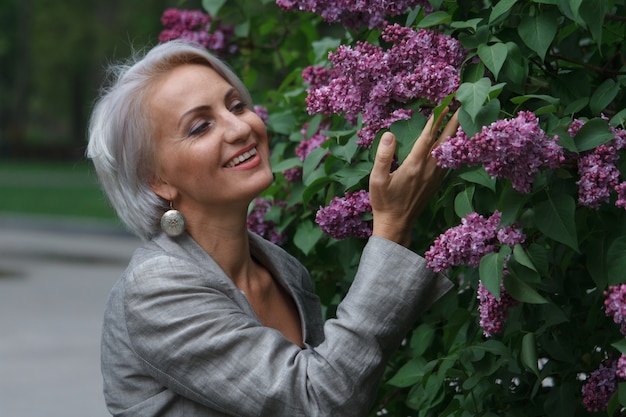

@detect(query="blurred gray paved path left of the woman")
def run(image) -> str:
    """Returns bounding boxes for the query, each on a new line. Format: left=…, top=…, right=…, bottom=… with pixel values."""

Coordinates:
left=0, top=216, right=139, bottom=417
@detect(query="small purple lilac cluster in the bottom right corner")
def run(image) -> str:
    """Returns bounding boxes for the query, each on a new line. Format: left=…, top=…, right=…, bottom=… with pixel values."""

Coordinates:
left=582, top=360, right=618, bottom=412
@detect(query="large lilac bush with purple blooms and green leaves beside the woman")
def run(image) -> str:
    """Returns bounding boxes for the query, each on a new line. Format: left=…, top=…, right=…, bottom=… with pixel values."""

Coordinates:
left=179, top=0, right=626, bottom=417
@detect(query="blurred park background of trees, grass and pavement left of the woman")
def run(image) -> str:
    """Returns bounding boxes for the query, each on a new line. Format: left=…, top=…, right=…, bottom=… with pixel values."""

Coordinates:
left=0, top=0, right=201, bottom=417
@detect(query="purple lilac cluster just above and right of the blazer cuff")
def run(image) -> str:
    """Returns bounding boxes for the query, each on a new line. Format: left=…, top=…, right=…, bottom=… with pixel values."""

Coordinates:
left=424, top=211, right=526, bottom=272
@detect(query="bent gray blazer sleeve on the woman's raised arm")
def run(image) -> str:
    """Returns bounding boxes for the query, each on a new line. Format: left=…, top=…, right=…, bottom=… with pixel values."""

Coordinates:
left=124, top=237, right=452, bottom=417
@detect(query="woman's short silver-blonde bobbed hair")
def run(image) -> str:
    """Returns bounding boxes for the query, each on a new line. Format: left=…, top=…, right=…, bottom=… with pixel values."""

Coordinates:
left=87, top=40, right=253, bottom=240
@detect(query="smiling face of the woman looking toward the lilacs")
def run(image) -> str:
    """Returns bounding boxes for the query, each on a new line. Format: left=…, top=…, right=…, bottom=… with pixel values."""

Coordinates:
left=149, top=64, right=273, bottom=216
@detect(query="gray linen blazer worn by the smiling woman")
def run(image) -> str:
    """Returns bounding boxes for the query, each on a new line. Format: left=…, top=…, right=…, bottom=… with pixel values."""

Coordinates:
left=102, top=234, right=452, bottom=417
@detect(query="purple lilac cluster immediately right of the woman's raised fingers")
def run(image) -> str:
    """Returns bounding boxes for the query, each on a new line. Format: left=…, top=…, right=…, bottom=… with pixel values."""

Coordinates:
left=433, top=111, right=565, bottom=193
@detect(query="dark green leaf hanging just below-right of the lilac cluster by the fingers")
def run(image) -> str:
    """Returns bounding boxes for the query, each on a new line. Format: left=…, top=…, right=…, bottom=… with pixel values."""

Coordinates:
left=535, top=194, right=578, bottom=252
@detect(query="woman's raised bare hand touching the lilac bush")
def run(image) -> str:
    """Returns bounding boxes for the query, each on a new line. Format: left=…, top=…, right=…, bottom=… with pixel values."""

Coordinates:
left=370, top=110, right=459, bottom=246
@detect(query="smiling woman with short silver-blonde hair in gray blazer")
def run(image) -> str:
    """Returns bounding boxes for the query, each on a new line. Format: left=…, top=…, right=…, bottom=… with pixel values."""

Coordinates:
left=88, top=41, right=458, bottom=417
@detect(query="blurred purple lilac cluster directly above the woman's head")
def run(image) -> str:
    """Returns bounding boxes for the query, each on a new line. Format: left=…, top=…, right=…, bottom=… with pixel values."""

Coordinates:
left=159, top=8, right=237, bottom=56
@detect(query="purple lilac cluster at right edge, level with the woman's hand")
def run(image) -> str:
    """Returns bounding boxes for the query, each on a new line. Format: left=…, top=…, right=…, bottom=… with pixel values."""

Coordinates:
left=567, top=119, right=626, bottom=209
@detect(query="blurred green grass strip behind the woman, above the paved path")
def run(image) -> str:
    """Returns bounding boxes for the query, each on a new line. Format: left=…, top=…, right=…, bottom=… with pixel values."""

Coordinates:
left=0, top=161, right=116, bottom=220
